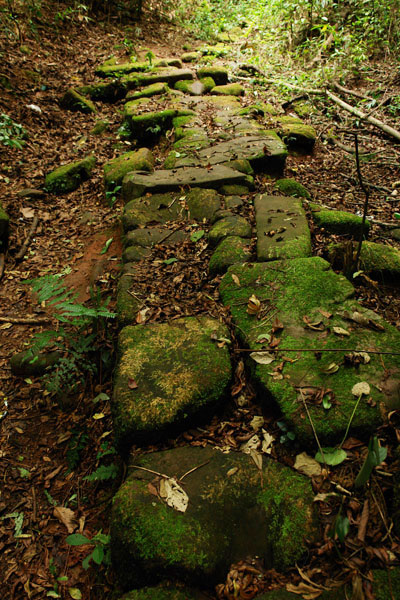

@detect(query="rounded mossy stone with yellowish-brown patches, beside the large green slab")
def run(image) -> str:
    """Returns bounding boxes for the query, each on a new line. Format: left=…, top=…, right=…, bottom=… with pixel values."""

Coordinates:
left=112, top=317, right=231, bottom=447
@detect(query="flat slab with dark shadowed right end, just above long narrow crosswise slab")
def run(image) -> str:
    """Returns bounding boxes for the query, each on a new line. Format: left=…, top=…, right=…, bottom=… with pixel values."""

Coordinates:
left=176, top=132, right=288, bottom=172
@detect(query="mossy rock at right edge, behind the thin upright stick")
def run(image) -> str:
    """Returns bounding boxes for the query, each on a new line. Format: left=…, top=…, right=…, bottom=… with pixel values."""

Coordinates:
left=329, top=241, right=400, bottom=285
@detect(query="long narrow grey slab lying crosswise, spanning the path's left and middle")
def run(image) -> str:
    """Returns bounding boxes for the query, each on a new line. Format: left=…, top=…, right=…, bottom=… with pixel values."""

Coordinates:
left=122, top=165, right=253, bottom=202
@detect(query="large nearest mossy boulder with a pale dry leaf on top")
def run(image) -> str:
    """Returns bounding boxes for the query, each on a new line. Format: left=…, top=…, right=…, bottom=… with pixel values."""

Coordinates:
left=111, top=446, right=318, bottom=589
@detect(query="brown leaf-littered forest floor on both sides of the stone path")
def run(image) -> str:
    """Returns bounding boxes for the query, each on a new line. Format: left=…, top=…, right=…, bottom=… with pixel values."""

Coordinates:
left=0, top=5, right=400, bottom=600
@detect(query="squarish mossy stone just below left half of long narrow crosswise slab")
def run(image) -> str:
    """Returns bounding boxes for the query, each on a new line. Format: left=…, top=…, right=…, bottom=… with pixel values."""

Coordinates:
left=122, top=194, right=185, bottom=232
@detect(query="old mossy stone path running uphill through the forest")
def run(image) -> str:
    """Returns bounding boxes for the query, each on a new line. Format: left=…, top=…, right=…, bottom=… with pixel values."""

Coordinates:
left=41, top=50, right=400, bottom=600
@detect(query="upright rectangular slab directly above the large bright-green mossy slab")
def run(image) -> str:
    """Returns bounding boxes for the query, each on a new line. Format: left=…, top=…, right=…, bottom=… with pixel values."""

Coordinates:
left=254, top=194, right=311, bottom=261
